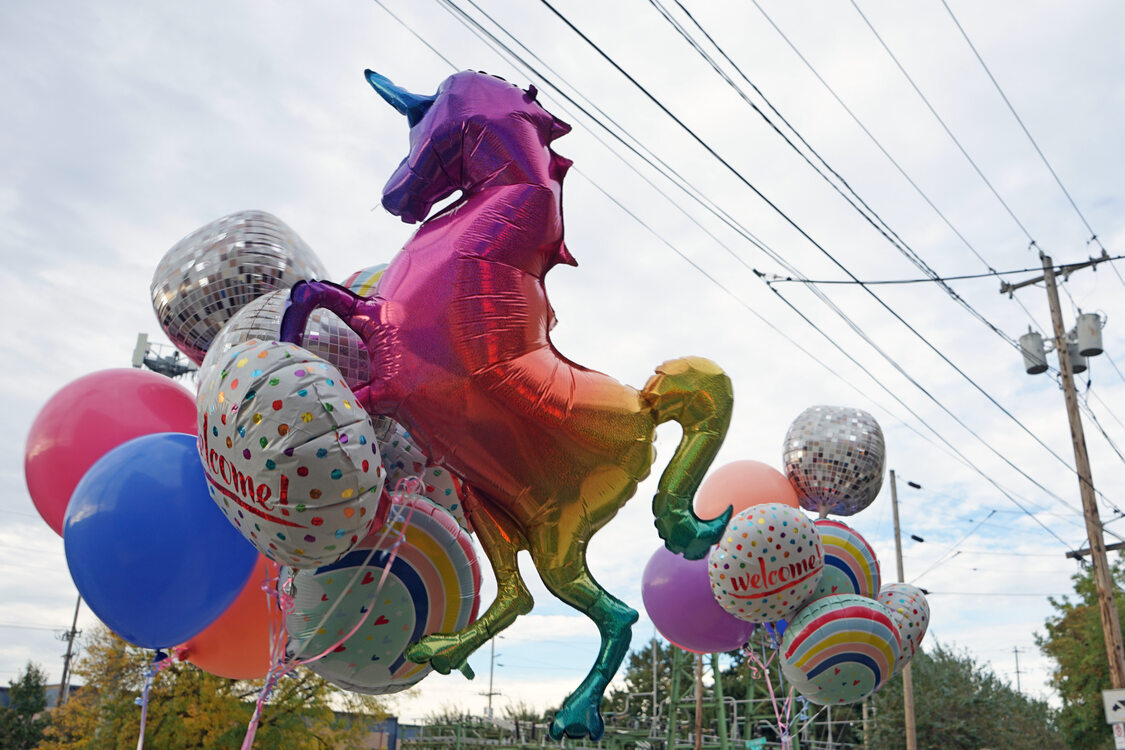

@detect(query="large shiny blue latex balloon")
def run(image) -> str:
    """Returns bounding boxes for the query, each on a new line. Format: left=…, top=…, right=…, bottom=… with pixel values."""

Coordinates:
left=63, top=433, right=258, bottom=649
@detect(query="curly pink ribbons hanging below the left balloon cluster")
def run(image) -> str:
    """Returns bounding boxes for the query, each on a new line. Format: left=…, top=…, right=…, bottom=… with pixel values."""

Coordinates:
left=240, top=477, right=424, bottom=750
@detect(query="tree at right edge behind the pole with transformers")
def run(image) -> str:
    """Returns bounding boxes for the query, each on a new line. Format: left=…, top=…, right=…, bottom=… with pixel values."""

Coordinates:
left=1035, top=555, right=1125, bottom=750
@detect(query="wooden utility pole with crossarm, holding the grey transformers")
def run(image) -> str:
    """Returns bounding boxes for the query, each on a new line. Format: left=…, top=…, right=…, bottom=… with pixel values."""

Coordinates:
left=1000, top=252, right=1125, bottom=689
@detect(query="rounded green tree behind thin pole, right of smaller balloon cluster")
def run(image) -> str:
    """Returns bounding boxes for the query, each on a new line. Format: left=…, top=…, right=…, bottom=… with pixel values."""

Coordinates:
left=867, top=643, right=1068, bottom=750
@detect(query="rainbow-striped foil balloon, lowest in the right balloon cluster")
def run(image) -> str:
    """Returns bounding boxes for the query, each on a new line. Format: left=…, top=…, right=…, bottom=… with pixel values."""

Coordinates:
left=780, top=594, right=902, bottom=705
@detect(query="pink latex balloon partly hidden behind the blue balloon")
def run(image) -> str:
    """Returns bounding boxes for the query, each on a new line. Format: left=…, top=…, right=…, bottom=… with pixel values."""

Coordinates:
left=24, top=369, right=196, bottom=536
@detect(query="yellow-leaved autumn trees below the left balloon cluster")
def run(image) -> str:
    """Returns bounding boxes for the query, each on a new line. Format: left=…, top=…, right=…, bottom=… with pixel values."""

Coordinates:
left=39, top=629, right=385, bottom=750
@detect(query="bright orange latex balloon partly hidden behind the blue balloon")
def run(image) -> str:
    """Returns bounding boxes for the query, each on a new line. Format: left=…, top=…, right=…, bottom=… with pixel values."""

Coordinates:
left=180, top=554, right=281, bottom=679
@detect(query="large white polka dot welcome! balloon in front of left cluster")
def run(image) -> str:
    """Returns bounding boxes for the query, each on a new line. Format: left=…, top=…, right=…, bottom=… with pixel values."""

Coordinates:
left=197, top=340, right=387, bottom=568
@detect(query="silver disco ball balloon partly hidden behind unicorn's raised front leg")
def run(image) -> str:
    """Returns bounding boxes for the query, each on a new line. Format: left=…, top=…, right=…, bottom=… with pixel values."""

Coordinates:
left=199, top=289, right=371, bottom=390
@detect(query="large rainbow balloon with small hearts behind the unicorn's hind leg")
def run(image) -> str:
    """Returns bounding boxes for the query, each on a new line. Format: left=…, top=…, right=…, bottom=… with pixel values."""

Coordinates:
left=282, top=496, right=480, bottom=695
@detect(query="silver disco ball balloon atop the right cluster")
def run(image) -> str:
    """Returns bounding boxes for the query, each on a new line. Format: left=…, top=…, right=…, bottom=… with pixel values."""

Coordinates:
left=784, top=406, right=887, bottom=516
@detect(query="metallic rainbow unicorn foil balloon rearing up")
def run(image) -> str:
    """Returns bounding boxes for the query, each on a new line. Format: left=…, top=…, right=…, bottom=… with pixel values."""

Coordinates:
left=281, top=71, right=732, bottom=739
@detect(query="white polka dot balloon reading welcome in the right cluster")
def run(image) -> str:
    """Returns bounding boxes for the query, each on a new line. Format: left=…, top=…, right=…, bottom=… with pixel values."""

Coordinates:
left=708, top=503, right=825, bottom=623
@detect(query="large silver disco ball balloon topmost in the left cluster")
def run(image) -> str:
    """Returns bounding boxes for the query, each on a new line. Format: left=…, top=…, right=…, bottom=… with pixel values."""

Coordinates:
left=152, top=211, right=327, bottom=364
